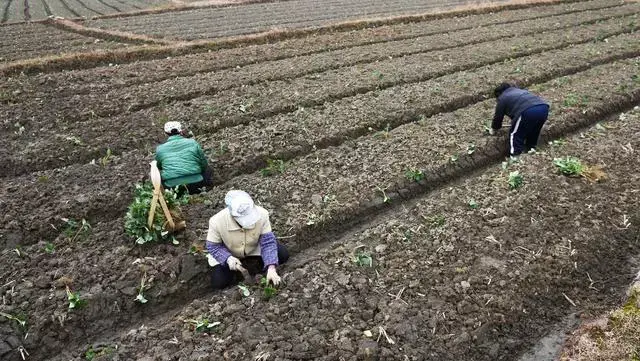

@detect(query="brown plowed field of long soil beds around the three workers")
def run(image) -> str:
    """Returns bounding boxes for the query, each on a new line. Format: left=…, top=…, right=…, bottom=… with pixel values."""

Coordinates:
left=0, top=0, right=640, bottom=361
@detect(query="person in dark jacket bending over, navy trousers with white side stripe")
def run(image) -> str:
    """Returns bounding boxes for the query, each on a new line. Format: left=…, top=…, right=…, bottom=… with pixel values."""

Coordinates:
left=489, top=83, right=549, bottom=156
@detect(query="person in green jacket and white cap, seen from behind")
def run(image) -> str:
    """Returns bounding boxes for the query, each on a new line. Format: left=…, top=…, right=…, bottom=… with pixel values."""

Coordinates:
left=156, top=122, right=213, bottom=194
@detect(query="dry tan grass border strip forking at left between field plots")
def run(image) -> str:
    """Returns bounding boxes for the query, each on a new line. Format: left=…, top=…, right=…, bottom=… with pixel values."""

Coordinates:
left=0, top=0, right=592, bottom=76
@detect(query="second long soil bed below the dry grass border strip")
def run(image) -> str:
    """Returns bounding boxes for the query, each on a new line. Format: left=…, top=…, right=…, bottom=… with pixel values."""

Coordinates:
left=16, top=4, right=640, bottom=118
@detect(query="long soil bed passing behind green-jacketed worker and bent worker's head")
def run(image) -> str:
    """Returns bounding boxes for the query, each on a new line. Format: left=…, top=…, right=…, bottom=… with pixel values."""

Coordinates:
left=2, top=35, right=640, bottom=253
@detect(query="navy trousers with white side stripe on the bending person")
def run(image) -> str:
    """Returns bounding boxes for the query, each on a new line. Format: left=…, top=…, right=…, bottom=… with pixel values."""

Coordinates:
left=509, top=104, right=549, bottom=155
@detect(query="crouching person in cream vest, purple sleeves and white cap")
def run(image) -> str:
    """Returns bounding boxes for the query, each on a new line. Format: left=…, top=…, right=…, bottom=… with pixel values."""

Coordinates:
left=206, top=190, right=289, bottom=289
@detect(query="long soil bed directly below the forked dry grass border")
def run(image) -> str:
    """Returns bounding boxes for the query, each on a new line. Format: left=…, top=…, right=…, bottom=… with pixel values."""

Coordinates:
left=5, top=0, right=619, bottom=95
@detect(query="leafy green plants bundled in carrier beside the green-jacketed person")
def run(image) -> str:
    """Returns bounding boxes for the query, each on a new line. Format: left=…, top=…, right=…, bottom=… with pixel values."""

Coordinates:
left=124, top=182, right=189, bottom=244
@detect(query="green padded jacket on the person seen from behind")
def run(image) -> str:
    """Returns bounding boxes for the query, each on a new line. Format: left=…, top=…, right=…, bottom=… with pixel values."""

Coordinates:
left=156, top=135, right=207, bottom=188
